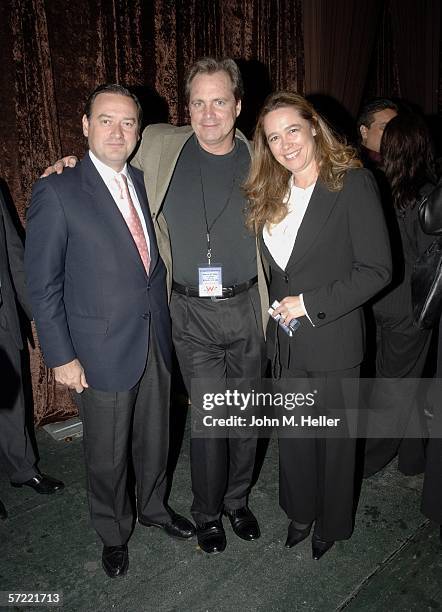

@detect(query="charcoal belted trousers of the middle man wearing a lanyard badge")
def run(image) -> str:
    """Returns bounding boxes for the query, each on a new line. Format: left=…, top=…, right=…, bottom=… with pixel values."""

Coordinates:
left=170, top=286, right=264, bottom=524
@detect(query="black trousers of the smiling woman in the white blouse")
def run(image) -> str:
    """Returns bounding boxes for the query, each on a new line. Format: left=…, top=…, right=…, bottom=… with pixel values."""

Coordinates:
left=279, top=367, right=359, bottom=540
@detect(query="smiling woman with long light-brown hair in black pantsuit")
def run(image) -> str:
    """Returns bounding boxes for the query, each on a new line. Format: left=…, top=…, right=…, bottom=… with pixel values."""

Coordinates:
left=246, top=92, right=391, bottom=559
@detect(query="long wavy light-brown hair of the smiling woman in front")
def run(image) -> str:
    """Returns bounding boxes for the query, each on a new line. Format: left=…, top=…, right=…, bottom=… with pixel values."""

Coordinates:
left=244, top=91, right=362, bottom=232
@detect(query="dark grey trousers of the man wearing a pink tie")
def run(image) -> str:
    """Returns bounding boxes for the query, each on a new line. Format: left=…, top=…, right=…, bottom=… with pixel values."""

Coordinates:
left=76, top=327, right=170, bottom=546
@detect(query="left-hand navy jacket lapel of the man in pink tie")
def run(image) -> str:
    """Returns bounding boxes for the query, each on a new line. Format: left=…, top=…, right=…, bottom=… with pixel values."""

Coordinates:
left=81, top=155, right=146, bottom=272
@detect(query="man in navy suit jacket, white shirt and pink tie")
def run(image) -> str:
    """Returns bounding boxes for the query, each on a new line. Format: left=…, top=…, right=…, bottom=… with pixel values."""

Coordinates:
left=26, top=85, right=194, bottom=577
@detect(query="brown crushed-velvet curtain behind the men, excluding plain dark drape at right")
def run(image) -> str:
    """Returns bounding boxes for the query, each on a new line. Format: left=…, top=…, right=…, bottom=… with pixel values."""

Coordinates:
left=0, top=0, right=304, bottom=423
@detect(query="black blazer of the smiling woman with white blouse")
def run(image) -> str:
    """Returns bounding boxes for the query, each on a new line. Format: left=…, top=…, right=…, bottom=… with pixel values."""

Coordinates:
left=261, top=168, right=391, bottom=371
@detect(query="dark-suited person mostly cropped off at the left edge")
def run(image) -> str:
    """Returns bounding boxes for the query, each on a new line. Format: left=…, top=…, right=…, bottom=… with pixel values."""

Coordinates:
left=0, top=189, right=64, bottom=518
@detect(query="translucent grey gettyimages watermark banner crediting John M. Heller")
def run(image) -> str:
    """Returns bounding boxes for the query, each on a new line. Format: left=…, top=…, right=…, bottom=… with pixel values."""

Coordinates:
left=191, top=377, right=442, bottom=438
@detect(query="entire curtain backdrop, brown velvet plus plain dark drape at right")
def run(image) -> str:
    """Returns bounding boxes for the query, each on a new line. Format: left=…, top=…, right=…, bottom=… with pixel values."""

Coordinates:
left=0, top=0, right=440, bottom=423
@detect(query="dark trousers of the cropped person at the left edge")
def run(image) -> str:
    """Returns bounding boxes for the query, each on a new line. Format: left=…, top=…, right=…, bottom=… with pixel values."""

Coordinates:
left=0, top=314, right=37, bottom=482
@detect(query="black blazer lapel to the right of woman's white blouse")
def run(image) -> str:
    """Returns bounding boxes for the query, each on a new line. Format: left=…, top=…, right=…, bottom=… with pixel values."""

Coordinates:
left=286, top=179, right=339, bottom=269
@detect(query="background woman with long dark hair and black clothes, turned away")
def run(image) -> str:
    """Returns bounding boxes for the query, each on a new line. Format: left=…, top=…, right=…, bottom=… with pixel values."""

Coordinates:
left=364, top=113, right=434, bottom=477
